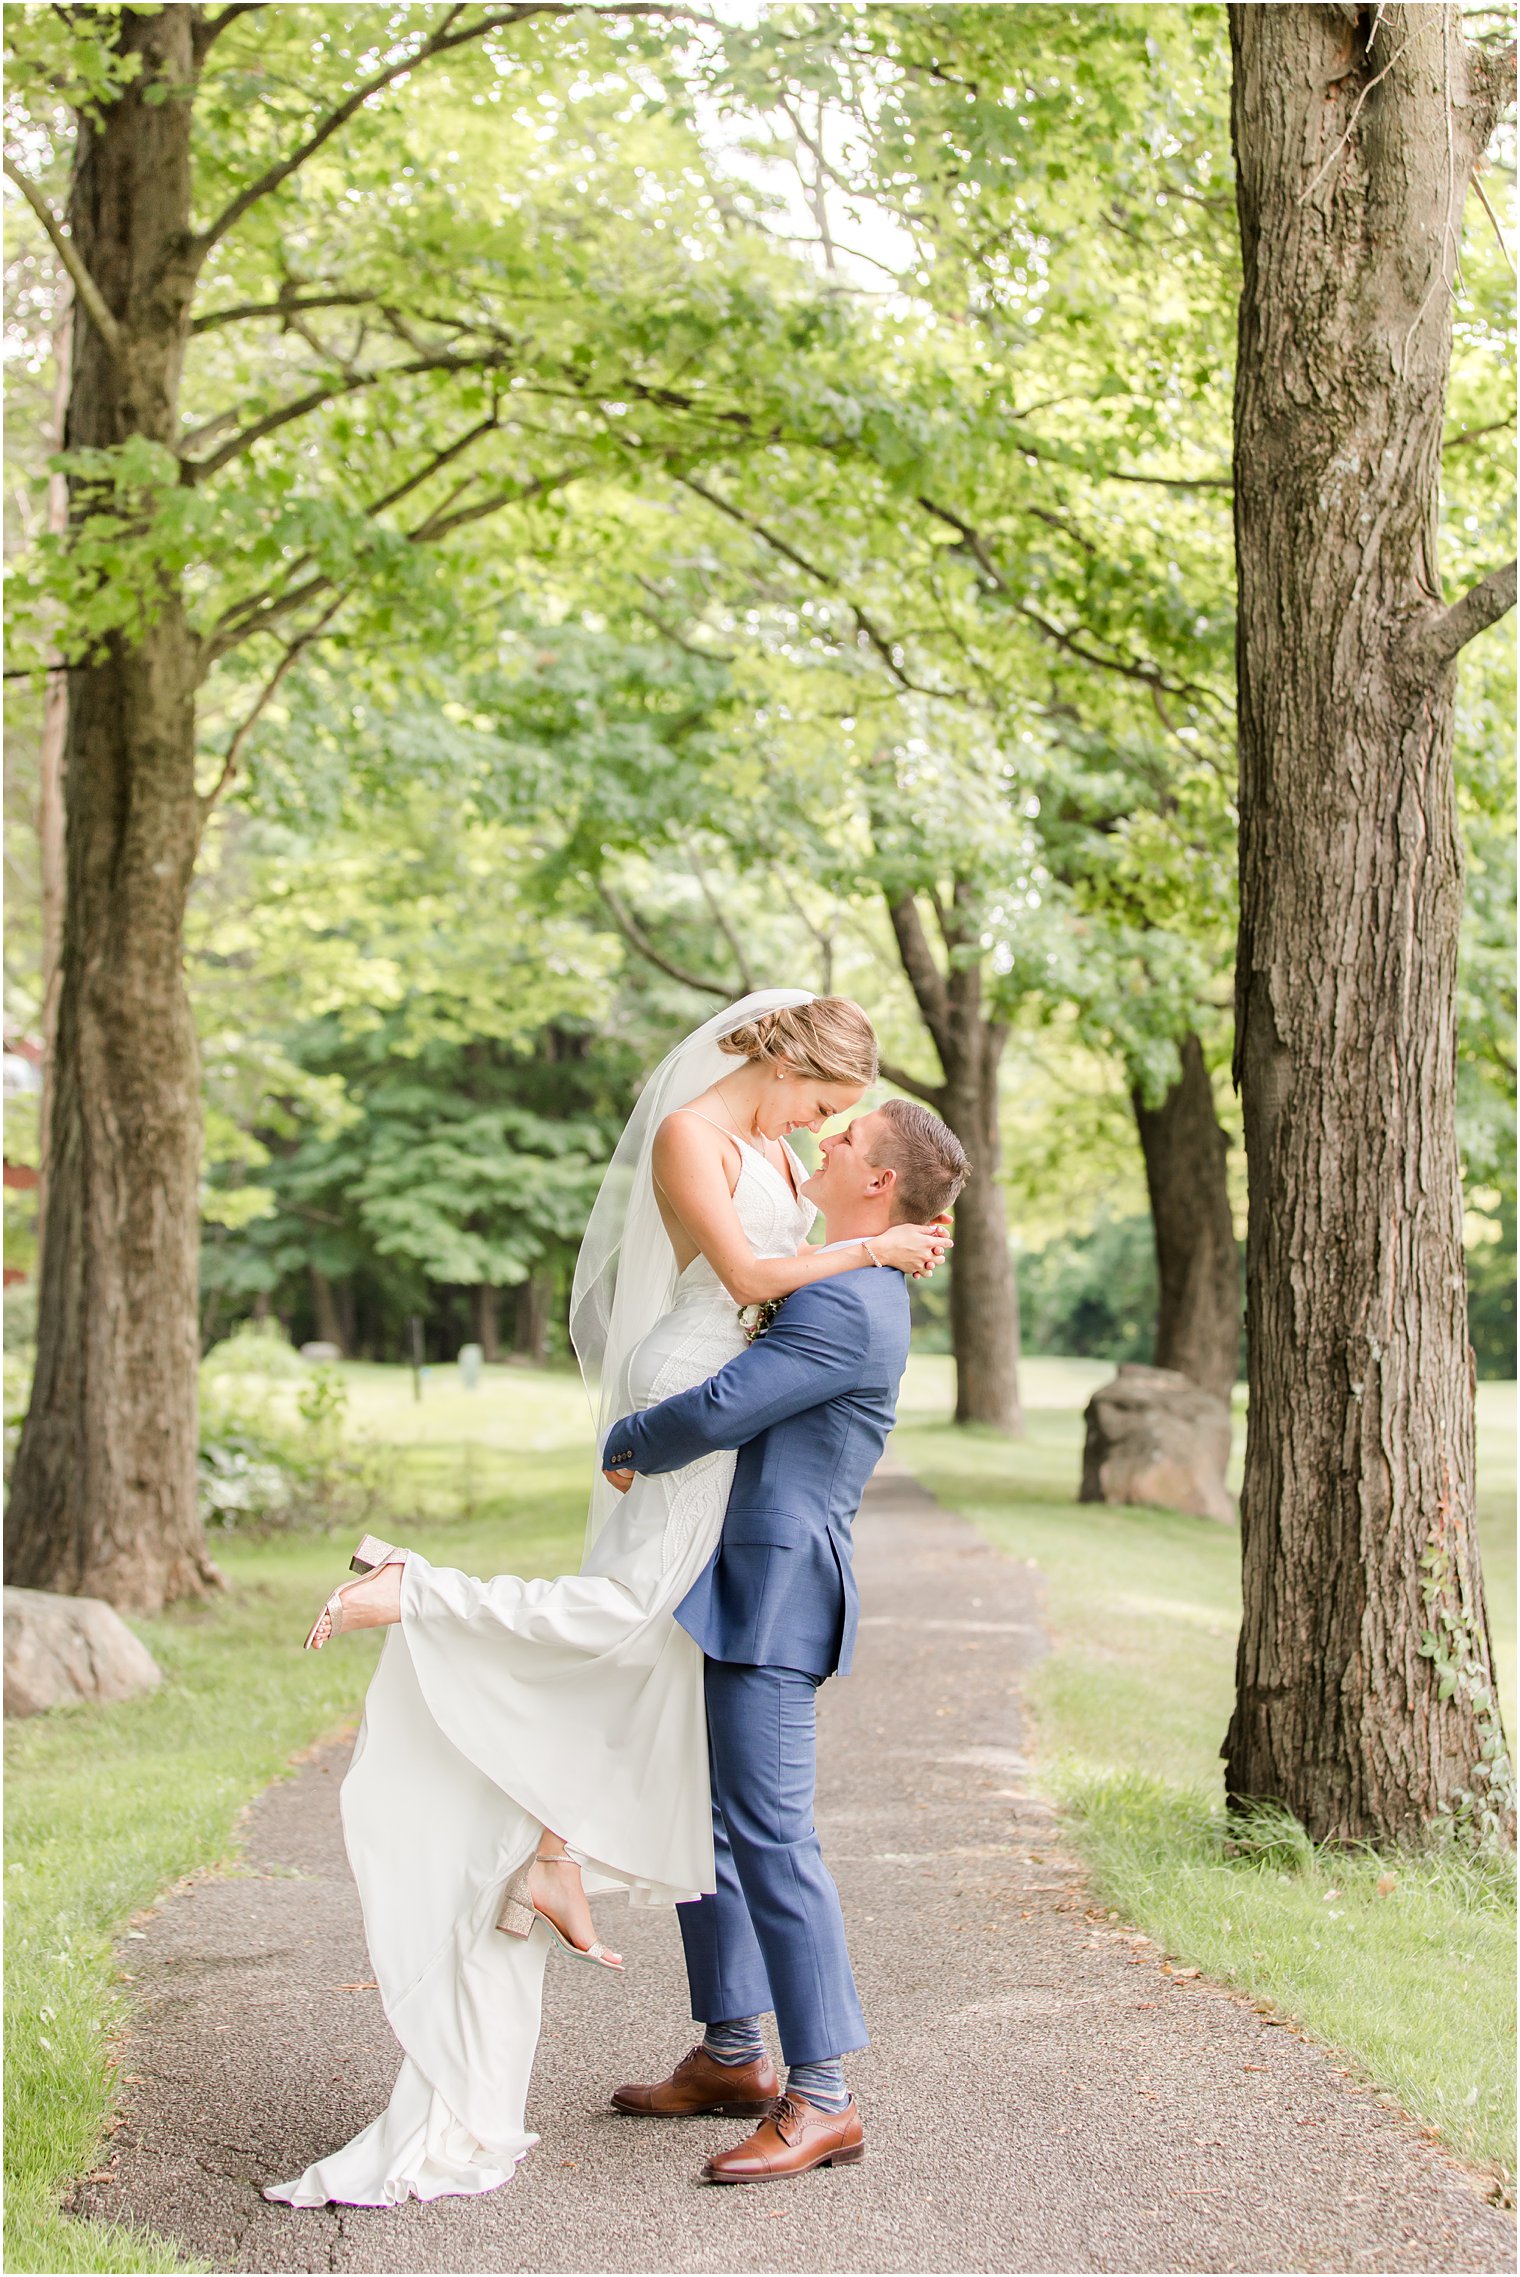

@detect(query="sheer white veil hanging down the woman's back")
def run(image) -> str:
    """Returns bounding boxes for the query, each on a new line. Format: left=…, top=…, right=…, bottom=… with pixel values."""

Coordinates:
left=569, top=988, right=812, bottom=1551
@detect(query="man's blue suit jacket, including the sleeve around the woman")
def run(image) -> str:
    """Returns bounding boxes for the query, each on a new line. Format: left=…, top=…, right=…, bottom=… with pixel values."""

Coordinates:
left=603, top=1266, right=908, bottom=1676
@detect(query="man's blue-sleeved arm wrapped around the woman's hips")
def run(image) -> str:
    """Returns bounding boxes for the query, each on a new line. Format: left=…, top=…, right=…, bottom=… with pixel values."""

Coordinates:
left=601, top=1280, right=869, bottom=1471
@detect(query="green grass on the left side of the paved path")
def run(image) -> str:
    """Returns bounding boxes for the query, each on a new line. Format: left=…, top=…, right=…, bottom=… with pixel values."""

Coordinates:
left=5, top=1368, right=589, bottom=2272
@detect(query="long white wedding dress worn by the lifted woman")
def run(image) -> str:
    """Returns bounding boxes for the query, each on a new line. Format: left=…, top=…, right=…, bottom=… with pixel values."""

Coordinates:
left=264, top=1148, right=817, bottom=2206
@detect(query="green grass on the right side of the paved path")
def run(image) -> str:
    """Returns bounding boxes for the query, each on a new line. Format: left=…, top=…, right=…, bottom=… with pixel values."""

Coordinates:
left=897, top=1362, right=1515, bottom=2172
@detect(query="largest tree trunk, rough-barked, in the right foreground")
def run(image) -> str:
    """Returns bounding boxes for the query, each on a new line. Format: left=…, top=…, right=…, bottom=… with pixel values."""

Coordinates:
left=1224, top=5, right=1513, bottom=1840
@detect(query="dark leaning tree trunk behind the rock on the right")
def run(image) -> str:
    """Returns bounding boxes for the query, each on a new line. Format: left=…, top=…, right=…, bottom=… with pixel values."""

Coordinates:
left=1131, top=1031, right=1240, bottom=1400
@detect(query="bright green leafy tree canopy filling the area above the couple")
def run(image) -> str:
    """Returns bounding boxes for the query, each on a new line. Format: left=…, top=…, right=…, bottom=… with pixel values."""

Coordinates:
left=7, top=5, right=1513, bottom=1334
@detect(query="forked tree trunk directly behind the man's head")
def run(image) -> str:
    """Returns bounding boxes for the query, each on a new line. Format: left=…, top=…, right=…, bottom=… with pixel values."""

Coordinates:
left=883, top=883, right=1024, bottom=1435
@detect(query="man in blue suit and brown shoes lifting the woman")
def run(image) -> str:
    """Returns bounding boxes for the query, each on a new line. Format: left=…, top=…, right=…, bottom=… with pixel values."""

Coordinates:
left=603, top=1100, right=969, bottom=2181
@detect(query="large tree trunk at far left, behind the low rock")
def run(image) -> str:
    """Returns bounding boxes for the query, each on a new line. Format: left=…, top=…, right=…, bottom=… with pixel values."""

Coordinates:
left=5, top=7, right=216, bottom=1610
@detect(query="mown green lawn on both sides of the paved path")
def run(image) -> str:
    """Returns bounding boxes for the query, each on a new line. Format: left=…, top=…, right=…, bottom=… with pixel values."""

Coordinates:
left=5, top=1357, right=1515, bottom=2272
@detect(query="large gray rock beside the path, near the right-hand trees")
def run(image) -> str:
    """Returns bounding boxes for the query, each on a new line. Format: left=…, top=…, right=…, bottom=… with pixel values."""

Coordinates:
left=1079, top=1362, right=1236, bottom=1526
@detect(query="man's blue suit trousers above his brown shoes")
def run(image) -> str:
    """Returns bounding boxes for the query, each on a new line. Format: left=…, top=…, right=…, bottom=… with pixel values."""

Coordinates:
left=676, top=1660, right=869, bottom=2063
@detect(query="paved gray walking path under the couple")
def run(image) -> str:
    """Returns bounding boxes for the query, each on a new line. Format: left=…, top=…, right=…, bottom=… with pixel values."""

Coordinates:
left=80, top=1475, right=1515, bottom=2272
